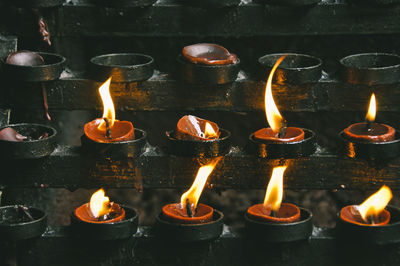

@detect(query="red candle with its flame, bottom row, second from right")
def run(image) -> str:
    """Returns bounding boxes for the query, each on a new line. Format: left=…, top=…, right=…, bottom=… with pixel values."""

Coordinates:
left=247, top=166, right=300, bottom=223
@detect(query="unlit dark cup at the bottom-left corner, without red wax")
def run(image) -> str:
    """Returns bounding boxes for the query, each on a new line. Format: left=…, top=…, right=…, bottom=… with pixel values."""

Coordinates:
left=0, top=205, right=47, bottom=241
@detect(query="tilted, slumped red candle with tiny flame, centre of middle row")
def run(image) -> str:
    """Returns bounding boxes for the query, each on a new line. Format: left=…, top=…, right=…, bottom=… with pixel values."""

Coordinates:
left=175, top=115, right=221, bottom=141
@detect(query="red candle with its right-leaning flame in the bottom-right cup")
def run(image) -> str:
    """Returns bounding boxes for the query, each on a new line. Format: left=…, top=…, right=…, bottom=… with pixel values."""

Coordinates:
left=340, top=186, right=392, bottom=226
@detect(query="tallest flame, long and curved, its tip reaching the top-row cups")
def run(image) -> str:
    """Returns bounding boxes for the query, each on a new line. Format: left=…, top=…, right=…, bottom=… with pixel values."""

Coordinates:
left=264, top=55, right=286, bottom=134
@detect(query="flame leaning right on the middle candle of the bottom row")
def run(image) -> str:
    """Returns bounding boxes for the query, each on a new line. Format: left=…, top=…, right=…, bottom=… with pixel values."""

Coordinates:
left=181, top=159, right=219, bottom=209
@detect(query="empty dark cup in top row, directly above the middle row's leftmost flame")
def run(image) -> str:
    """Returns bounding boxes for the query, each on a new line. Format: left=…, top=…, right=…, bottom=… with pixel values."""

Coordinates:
left=89, top=53, right=154, bottom=82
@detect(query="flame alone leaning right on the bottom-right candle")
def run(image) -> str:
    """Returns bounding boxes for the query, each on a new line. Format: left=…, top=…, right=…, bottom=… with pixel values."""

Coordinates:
left=358, top=186, right=393, bottom=222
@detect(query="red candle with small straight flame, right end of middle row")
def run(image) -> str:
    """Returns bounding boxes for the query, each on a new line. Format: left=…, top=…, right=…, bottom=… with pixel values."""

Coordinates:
left=343, top=93, right=396, bottom=142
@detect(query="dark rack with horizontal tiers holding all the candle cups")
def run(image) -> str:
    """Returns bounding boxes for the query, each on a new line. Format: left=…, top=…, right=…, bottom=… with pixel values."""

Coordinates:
left=0, top=0, right=400, bottom=265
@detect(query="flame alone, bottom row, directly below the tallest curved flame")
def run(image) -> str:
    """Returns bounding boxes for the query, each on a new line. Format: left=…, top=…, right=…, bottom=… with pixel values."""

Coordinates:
left=264, top=166, right=287, bottom=212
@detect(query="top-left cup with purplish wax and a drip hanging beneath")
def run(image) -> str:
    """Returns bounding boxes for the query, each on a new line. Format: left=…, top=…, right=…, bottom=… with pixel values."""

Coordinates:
left=4, top=50, right=65, bottom=121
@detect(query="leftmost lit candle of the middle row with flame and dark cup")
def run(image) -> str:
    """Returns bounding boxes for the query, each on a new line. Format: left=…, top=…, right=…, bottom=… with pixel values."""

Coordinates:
left=81, top=78, right=146, bottom=157
